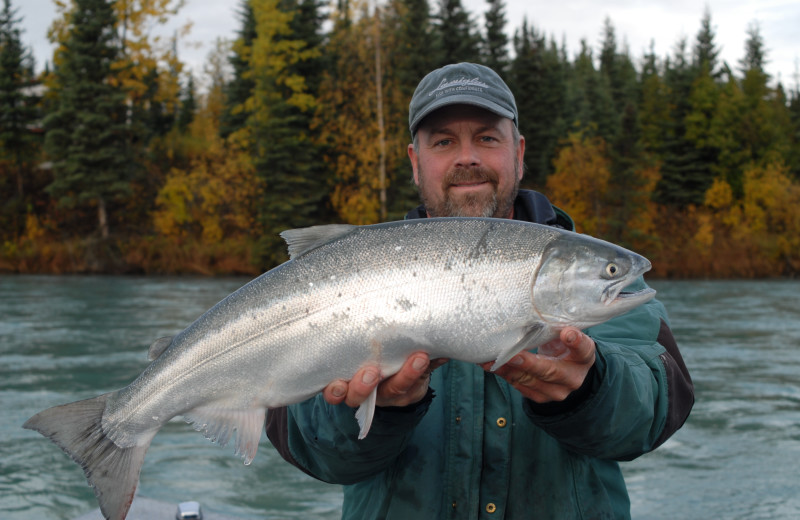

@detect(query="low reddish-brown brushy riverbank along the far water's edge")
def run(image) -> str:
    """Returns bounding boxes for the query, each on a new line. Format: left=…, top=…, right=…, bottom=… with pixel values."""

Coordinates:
left=0, top=222, right=800, bottom=280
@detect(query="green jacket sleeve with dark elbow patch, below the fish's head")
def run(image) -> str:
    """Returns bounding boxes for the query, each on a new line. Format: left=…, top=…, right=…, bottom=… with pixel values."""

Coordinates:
left=525, top=279, right=694, bottom=460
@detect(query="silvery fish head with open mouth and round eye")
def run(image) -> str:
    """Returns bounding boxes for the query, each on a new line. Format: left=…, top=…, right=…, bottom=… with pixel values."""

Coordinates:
left=532, top=232, right=656, bottom=329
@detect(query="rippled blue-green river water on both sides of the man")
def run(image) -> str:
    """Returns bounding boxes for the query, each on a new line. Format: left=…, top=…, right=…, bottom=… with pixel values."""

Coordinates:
left=0, top=276, right=800, bottom=520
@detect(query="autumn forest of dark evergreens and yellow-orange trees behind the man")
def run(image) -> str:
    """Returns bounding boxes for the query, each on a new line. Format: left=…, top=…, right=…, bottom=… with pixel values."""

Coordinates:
left=0, top=0, right=800, bottom=278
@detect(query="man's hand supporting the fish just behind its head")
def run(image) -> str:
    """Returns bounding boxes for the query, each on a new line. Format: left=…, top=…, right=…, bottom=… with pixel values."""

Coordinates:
left=481, top=327, right=596, bottom=403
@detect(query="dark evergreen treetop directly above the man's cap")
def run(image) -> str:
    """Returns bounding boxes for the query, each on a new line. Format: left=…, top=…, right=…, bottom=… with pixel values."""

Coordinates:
left=436, top=0, right=481, bottom=66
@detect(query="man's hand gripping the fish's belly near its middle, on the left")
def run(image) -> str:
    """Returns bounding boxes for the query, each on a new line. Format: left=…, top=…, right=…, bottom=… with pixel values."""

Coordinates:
left=322, top=352, right=447, bottom=408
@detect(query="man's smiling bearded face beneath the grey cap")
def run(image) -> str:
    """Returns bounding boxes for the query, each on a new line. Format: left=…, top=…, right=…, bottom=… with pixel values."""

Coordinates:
left=408, top=105, right=525, bottom=218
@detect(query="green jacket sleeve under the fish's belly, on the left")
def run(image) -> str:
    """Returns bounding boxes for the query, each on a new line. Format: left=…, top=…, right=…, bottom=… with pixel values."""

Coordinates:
left=266, top=389, right=433, bottom=484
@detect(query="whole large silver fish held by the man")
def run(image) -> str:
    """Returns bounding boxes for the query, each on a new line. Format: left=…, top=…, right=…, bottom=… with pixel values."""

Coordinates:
left=23, top=217, right=655, bottom=520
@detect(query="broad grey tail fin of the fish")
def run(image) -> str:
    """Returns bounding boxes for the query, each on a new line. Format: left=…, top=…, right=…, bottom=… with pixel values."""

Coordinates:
left=22, top=394, right=152, bottom=520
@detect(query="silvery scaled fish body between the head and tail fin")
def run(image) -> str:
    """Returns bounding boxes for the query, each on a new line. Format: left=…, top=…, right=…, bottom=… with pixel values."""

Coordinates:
left=104, top=220, right=558, bottom=431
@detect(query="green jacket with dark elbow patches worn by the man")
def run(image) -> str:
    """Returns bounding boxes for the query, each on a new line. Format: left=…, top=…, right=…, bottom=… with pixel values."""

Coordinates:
left=267, top=192, right=694, bottom=520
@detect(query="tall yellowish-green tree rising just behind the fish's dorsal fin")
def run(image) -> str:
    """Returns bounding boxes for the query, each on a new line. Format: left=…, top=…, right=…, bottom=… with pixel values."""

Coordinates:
left=247, top=0, right=327, bottom=266
